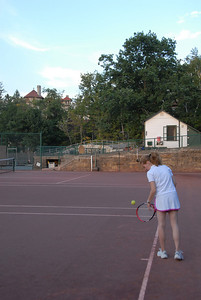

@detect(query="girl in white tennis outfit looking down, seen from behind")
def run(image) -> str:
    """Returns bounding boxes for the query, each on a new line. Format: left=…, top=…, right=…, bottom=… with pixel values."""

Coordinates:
left=141, top=152, right=184, bottom=260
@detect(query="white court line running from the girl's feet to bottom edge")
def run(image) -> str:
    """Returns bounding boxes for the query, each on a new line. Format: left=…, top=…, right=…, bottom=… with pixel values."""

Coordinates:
left=138, top=228, right=158, bottom=300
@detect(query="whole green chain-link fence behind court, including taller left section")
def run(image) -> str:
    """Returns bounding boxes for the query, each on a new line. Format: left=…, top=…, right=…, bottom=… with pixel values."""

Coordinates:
left=0, top=133, right=201, bottom=169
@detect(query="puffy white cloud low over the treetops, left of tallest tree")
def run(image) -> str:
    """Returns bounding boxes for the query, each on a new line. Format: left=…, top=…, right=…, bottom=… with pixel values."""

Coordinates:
left=40, top=67, right=81, bottom=88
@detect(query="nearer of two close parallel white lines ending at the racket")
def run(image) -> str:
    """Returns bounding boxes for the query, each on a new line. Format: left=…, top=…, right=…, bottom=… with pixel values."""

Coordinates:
left=0, top=211, right=136, bottom=218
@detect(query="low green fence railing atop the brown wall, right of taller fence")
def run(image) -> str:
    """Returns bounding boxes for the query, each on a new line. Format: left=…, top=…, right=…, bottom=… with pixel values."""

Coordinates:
left=36, top=134, right=201, bottom=159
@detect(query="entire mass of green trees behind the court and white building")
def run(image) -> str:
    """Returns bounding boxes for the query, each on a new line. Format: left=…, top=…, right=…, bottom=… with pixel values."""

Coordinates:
left=0, top=31, right=201, bottom=145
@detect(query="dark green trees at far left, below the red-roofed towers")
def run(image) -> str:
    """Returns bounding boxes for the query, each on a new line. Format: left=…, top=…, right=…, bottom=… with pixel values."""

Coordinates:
left=0, top=86, right=66, bottom=145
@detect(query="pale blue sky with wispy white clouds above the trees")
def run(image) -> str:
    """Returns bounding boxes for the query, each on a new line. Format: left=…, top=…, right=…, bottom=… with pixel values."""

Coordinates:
left=0, top=0, right=201, bottom=98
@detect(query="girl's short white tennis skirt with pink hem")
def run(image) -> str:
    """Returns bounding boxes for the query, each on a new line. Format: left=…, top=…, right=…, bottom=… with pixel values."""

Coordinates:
left=155, top=191, right=180, bottom=211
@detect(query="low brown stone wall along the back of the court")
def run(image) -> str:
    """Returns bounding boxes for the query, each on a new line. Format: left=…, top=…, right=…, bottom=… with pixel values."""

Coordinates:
left=58, top=149, right=201, bottom=172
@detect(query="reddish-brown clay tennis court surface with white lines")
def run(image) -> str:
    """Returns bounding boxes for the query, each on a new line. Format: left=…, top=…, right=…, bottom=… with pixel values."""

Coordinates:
left=0, top=171, right=201, bottom=300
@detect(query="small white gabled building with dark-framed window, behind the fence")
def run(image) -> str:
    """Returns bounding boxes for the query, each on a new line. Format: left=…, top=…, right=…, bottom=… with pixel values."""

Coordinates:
left=145, top=111, right=201, bottom=148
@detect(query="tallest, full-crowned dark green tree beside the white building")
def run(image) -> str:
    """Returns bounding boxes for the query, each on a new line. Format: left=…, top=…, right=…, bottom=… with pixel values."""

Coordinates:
left=96, top=32, right=178, bottom=137
